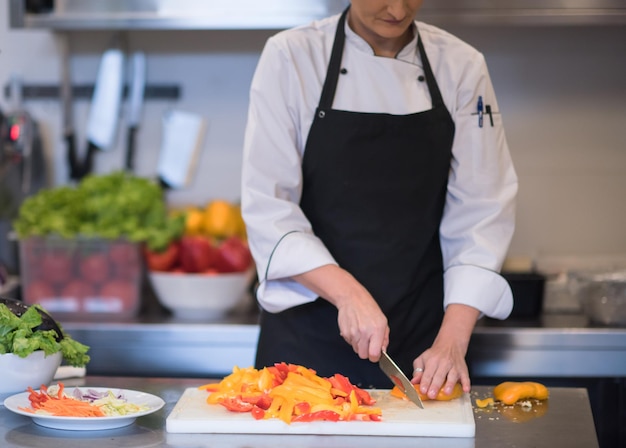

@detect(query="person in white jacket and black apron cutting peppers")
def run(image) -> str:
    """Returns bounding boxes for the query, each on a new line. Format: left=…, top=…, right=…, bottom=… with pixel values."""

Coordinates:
left=242, top=0, right=517, bottom=398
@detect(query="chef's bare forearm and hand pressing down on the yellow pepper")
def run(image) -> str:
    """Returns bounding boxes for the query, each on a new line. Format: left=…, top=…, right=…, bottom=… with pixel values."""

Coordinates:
left=411, top=304, right=480, bottom=399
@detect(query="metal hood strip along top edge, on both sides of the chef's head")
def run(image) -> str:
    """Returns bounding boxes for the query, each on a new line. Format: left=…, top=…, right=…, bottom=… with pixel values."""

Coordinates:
left=9, top=0, right=626, bottom=31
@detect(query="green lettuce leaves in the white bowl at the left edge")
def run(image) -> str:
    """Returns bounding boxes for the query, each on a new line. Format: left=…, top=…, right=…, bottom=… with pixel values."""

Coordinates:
left=0, top=303, right=90, bottom=367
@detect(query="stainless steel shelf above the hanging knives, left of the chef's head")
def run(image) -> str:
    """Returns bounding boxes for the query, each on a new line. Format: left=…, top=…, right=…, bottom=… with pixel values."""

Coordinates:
left=10, top=0, right=348, bottom=31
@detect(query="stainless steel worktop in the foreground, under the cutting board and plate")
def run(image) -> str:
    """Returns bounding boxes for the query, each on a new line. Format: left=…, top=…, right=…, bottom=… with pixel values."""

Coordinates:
left=0, top=376, right=598, bottom=448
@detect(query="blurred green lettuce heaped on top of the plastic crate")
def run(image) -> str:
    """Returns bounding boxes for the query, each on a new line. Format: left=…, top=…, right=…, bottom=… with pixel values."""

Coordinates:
left=13, top=171, right=185, bottom=250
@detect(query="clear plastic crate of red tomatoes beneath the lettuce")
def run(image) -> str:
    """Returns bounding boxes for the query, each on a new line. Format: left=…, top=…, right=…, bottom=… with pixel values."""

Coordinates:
left=19, top=237, right=143, bottom=320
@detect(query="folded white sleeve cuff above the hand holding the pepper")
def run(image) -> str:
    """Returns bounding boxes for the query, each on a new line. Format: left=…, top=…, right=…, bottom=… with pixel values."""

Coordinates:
left=443, top=265, right=513, bottom=320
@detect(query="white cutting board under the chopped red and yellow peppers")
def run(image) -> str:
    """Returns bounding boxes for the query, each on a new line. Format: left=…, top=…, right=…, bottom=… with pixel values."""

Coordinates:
left=166, top=388, right=476, bottom=437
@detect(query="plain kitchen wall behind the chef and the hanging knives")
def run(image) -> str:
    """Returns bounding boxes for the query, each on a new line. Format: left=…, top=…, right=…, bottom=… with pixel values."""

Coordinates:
left=0, top=6, right=626, bottom=270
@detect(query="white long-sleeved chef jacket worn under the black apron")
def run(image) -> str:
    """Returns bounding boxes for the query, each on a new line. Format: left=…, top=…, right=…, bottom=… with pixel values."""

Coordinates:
left=242, top=15, right=517, bottom=319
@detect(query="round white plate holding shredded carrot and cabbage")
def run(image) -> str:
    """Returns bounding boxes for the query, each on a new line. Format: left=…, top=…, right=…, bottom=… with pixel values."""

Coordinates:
left=4, top=387, right=165, bottom=431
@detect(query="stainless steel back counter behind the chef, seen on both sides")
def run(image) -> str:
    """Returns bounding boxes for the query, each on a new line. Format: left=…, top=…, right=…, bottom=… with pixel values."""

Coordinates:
left=58, top=313, right=626, bottom=378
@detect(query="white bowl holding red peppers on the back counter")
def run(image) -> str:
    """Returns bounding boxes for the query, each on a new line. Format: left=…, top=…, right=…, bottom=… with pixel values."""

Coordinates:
left=149, top=269, right=255, bottom=320
